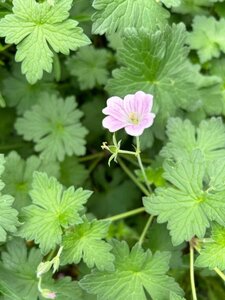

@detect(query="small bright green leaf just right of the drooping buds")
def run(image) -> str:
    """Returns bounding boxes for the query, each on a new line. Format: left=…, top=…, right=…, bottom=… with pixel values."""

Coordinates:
left=61, top=220, right=114, bottom=271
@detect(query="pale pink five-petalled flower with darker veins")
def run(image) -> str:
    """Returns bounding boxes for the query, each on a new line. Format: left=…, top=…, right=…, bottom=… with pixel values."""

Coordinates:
left=102, top=91, right=155, bottom=136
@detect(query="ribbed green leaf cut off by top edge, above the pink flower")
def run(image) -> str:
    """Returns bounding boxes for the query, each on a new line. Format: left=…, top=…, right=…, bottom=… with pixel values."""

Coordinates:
left=92, top=0, right=169, bottom=34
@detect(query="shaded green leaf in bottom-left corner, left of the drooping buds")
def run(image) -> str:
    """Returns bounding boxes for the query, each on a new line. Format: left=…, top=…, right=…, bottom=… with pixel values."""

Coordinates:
left=0, top=239, right=42, bottom=300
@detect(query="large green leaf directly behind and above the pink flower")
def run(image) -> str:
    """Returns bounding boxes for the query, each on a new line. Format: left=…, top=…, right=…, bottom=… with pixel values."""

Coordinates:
left=106, top=24, right=197, bottom=138
